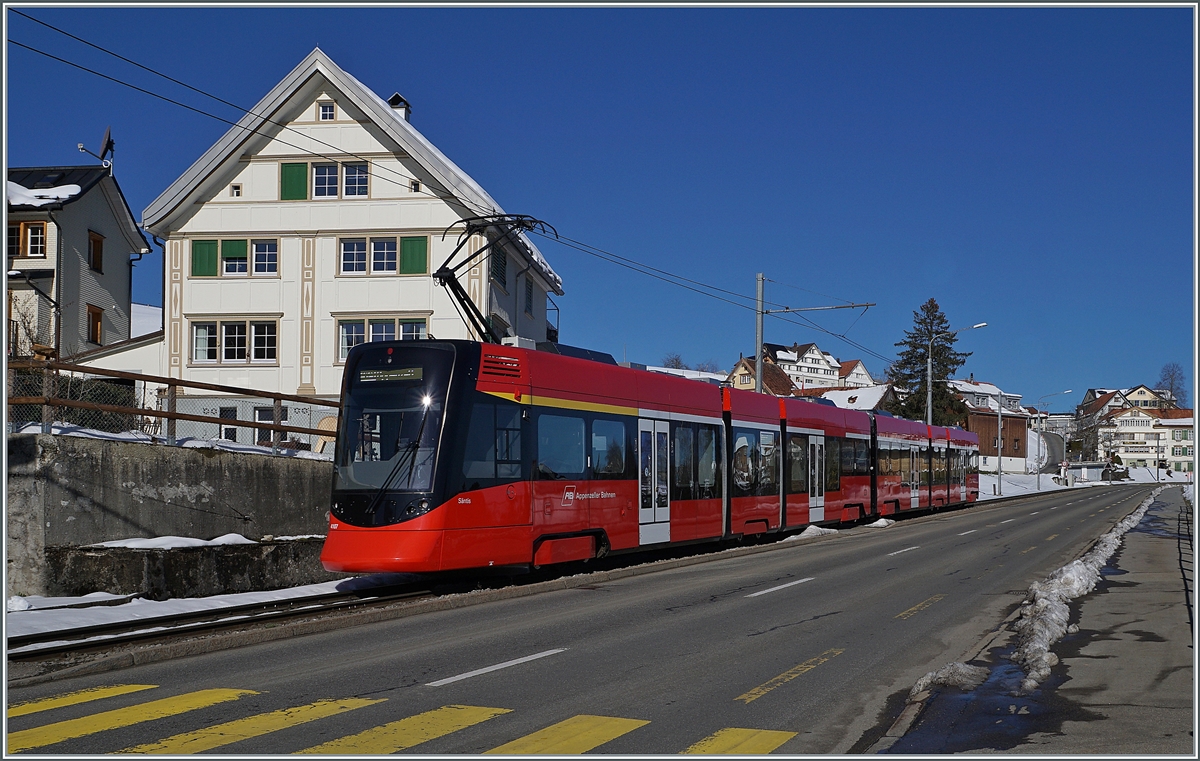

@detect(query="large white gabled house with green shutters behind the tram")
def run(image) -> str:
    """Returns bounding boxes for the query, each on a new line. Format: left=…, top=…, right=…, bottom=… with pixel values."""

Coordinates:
left=81, top=49, right=563, bottom=444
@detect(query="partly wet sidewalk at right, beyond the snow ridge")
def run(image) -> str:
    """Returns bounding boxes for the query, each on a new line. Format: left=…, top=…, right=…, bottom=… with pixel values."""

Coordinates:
left=882, top=489, right=1196, bottom=757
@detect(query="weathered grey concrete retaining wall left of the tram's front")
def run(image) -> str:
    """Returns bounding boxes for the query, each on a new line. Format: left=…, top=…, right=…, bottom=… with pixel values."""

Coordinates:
left=5, top=435, right=332, bottom=597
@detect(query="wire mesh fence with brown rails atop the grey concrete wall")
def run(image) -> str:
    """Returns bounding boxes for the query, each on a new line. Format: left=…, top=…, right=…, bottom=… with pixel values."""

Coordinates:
left=7, top=360, right=340, bottom=457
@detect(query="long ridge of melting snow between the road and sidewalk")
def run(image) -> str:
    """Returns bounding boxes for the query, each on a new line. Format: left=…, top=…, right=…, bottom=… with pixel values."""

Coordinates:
left=1012, top=486, right=1166, bottom=694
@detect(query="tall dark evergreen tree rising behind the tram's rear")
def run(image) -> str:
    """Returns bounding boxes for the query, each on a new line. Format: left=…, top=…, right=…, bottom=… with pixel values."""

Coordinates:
left=888, top=299, right=971, bottom=425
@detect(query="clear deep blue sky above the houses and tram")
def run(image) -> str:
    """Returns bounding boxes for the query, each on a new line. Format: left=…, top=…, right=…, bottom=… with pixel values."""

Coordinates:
left=5, top=6, right=1195, bottom=409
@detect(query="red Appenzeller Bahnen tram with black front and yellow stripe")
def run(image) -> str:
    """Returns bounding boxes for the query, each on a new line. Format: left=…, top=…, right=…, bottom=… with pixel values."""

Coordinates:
left=322, top=341, right=979, bottom=573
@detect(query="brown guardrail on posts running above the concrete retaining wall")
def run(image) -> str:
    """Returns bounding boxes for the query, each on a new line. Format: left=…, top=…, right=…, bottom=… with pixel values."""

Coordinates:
left=7, top=360, right=341, bottom=453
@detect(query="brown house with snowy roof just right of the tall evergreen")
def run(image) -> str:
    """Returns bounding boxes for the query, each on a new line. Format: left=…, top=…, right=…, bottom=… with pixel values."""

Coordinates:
left=947, top=377, right=1031, bottom=473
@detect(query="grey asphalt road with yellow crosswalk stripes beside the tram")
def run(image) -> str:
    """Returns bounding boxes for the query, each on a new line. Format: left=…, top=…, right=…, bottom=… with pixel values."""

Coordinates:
left=7, top=486, right=1151, bottom=755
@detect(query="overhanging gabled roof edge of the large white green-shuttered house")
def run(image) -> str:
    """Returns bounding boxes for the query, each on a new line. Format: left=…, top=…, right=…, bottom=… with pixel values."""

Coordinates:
left=142, top=48, right=563, bottom=290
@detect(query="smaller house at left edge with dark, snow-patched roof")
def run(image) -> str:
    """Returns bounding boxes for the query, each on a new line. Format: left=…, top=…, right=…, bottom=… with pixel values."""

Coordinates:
left=6, top=166, right=150, bottom=359
